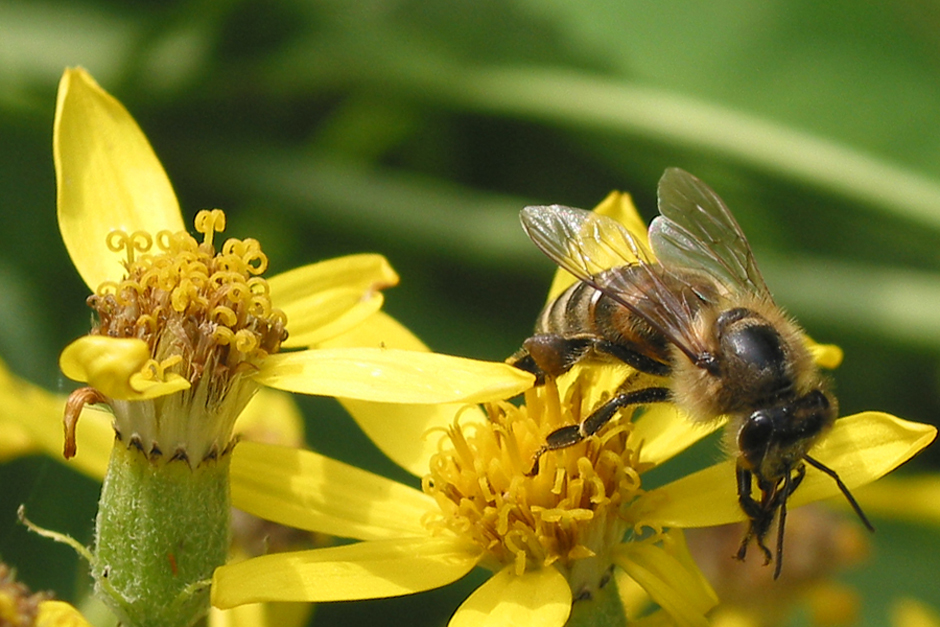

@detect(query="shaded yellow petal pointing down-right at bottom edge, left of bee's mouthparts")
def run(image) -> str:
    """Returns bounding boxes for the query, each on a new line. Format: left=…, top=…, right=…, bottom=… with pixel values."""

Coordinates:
left=614, top=542, right=718, bottom=627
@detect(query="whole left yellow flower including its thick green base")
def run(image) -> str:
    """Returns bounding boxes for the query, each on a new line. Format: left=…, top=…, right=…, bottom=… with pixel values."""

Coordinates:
left=46, top=69, right=532, bottom=627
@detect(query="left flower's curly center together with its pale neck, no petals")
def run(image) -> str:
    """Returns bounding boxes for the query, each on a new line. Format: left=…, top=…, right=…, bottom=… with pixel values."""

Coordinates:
left=76, top=209, right=287, bottom=463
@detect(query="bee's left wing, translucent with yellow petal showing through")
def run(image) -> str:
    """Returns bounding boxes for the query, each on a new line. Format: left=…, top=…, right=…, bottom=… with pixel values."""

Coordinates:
left=520, top=205, right=708, bottom=361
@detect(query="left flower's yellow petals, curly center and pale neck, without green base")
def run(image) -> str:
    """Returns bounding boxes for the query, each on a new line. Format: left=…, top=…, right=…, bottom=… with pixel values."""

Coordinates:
left=54, top=69, right=529, bottom=472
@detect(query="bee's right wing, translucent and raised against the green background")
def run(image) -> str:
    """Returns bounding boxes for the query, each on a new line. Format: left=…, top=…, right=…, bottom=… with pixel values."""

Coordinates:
left=649, top=168, right=770, bottom=298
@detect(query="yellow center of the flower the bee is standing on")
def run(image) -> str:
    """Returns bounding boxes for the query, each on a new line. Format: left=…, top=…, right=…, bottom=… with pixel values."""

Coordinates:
left=423, top=371, right=646, bottom=598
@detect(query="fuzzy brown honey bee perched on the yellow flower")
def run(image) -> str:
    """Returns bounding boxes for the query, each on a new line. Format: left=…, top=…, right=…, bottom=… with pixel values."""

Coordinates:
left=509, top=168, right=874, bottom=578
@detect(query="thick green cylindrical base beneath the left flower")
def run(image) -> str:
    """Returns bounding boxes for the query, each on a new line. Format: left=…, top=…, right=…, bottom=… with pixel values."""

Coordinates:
left=92, top=442, right=231, bottom=627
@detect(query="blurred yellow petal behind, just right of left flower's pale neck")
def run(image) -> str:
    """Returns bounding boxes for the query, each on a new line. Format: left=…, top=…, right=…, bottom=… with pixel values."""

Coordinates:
left=235, top=388, right=305, bottom=448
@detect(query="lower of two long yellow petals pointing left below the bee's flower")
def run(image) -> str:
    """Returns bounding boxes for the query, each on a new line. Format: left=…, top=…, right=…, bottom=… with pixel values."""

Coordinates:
left=212, top=536, right=481, bottom=609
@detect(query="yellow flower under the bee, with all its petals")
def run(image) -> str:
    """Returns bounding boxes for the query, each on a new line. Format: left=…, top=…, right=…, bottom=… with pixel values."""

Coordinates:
left=212, top=195, right=935, bottom=626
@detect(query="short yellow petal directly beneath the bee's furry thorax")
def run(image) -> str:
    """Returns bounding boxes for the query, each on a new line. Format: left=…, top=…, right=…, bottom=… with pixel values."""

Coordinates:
left=629, top=403, right=724, bottom=466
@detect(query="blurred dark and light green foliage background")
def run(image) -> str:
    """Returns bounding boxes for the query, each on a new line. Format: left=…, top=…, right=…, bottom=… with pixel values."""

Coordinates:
left=0, top=0, right=940, bottom=625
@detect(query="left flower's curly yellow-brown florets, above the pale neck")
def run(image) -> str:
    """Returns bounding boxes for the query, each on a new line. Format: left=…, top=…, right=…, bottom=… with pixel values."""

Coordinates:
left=88, top=209, right=287, bottom=378
